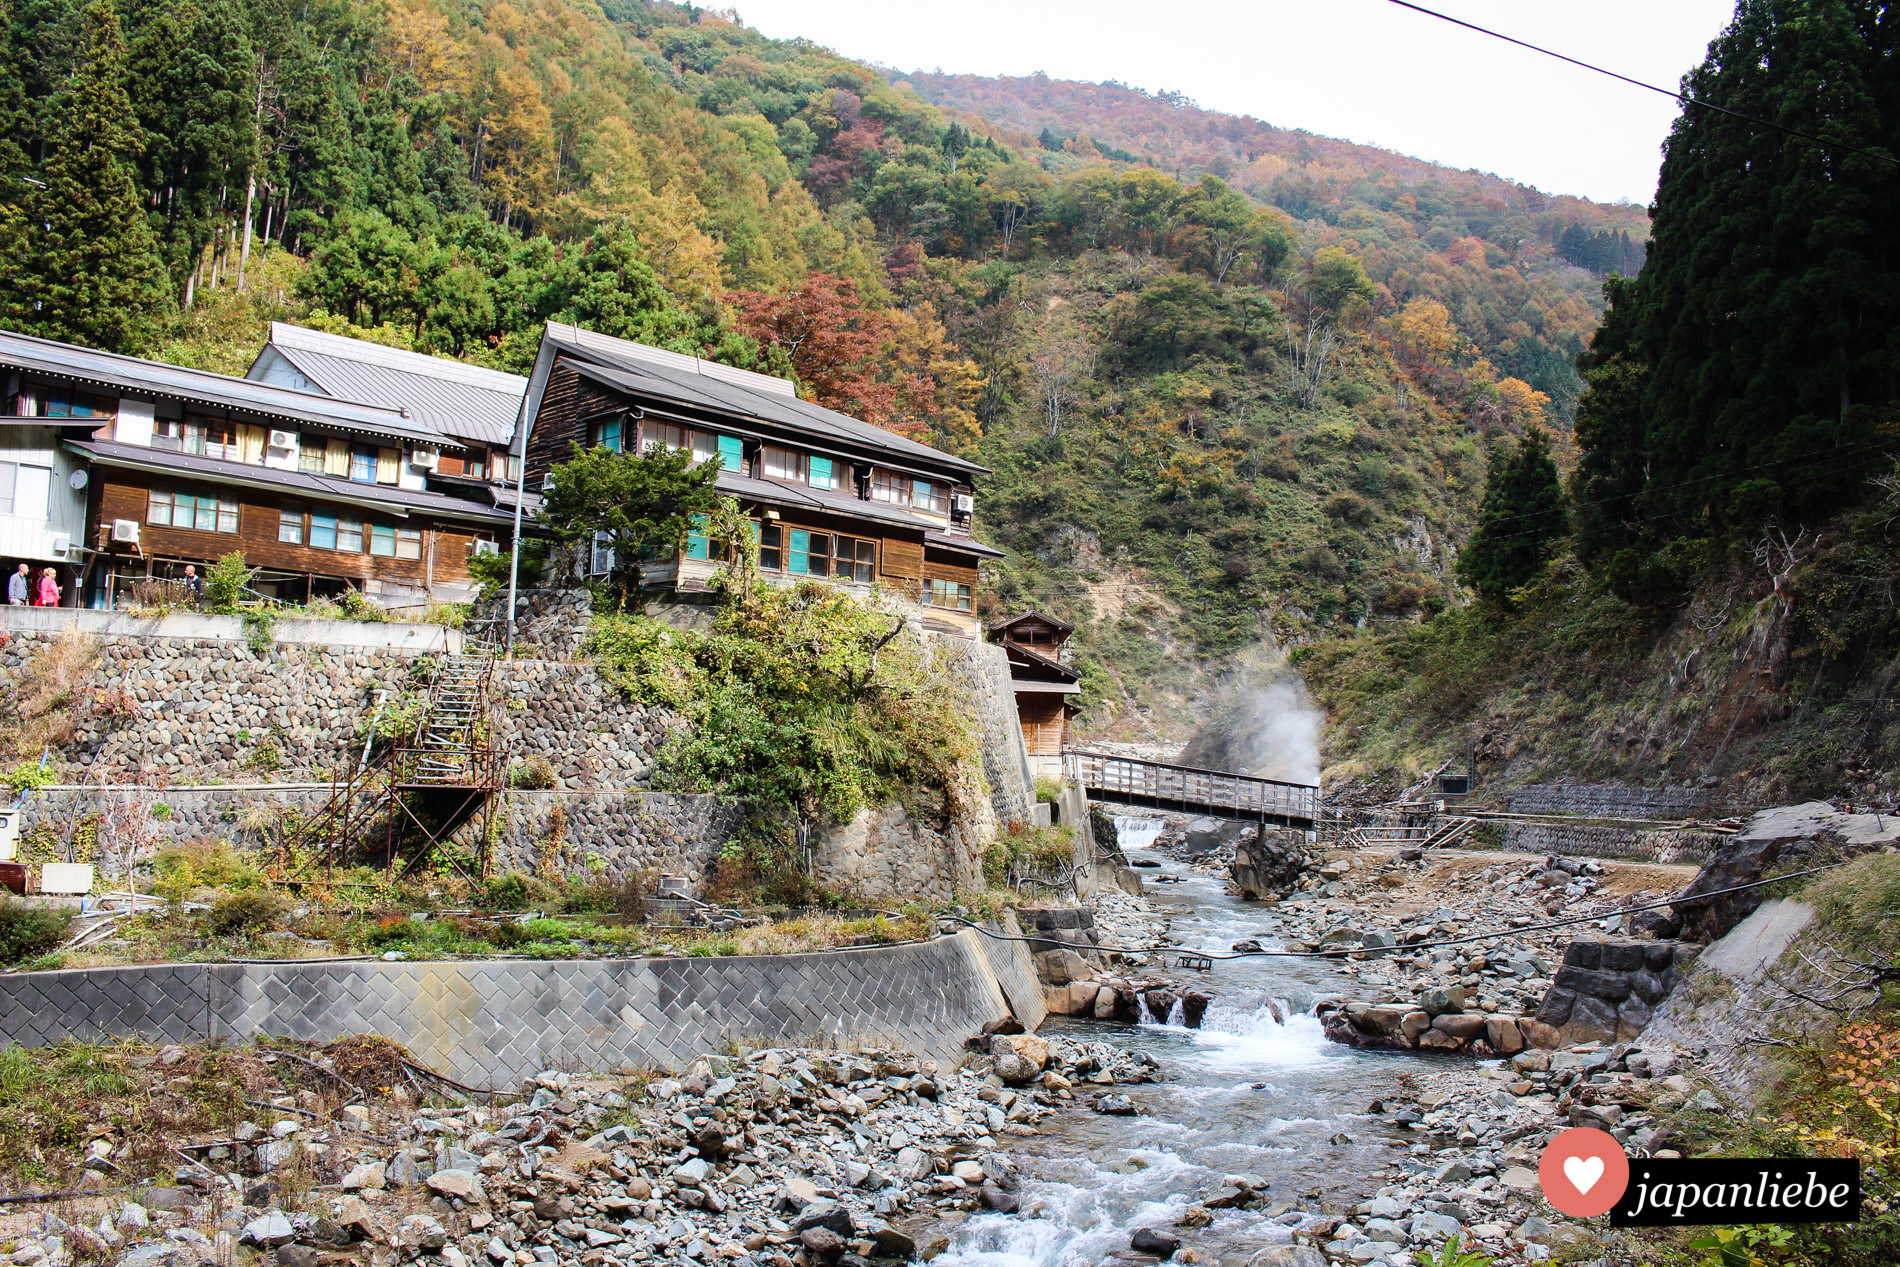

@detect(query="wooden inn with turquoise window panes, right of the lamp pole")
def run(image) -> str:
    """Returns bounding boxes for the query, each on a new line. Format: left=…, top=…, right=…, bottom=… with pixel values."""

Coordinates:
left=524, top=323, right=1001, bottom=638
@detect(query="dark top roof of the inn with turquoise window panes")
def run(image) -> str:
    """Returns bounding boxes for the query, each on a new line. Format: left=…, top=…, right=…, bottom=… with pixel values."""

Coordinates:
left=543, top=321, right=990, bottom=477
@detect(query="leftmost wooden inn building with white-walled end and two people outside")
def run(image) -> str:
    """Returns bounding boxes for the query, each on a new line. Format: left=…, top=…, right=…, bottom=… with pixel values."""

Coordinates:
left=0, top=332, right=513, bottom=606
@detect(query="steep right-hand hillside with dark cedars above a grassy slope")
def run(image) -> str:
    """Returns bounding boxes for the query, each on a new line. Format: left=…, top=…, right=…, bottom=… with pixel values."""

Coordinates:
left=1303, top=0, right=1900, bottom=804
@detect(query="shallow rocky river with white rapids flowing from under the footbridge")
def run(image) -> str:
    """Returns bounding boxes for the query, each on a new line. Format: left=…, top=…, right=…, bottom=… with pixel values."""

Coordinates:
left=935, top=830, right=1421, bottom=1267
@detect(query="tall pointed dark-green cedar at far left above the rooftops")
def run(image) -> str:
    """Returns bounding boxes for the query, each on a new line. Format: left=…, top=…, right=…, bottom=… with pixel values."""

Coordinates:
left=0, top=0, right=165, bottom=351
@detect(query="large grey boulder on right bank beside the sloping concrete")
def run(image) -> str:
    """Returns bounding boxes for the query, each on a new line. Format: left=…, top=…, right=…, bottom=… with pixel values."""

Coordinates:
left=1674, top=802, right=1900, bottom=942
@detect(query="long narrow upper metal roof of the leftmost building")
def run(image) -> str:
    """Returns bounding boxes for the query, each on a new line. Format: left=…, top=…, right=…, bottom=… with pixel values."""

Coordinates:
left=0, top=331, right=448, bottom=444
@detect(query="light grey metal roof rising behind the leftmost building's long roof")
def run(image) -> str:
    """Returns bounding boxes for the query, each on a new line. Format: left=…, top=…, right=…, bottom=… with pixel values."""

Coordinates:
left=251, top=321, right=528, bottom=444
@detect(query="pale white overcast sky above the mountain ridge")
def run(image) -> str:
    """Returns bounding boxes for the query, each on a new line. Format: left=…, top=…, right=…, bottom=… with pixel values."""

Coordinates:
left=737, top=0, right=1735, bottom=203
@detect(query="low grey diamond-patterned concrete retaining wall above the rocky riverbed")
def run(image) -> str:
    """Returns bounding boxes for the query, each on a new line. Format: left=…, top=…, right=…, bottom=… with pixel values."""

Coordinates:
left=0, top=931, right=1041, bottom=1087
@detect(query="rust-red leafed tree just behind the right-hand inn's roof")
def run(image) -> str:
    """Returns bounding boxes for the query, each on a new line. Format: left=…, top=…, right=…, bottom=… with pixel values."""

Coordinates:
left=726, top=274, right=897, bottom=425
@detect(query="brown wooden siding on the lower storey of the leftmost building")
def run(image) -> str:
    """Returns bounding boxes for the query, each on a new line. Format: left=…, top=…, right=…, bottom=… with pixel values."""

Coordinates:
left=91, top=469, right=500, bottom=585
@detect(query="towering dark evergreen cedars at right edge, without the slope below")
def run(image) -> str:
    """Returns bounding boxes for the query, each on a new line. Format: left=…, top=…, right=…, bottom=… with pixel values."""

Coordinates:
left=1575, top=0, right=1900, bottom=596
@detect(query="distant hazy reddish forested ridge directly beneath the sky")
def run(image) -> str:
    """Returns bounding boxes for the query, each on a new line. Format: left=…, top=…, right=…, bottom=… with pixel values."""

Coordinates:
left=887, top=72, right=1649, bottom=420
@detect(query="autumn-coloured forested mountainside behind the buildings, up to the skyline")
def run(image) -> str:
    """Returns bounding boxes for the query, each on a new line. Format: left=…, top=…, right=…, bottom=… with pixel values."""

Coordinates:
left=0, top=0, right=1642, bottom=733
